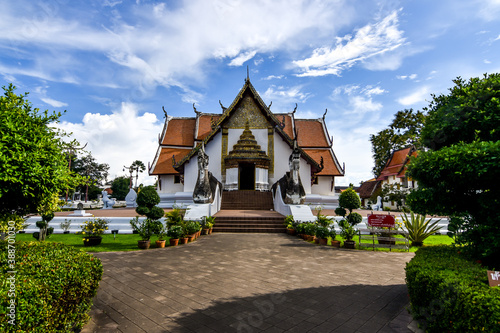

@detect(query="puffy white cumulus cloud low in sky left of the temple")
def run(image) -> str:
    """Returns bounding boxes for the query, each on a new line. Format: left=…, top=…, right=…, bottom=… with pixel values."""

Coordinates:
left=56, top=103, right=163, bottom=185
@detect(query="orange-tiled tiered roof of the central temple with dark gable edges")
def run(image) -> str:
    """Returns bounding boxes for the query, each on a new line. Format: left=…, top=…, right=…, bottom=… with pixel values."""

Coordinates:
left=149, top=79, right=344, bottom=176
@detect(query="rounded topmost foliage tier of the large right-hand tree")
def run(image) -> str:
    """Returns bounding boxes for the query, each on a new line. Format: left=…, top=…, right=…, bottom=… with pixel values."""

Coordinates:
left=422, top=73, right=500, bottom=150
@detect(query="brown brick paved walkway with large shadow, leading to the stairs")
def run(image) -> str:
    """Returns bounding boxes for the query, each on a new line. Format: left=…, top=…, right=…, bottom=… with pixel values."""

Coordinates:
left=82, top=233, right=413, bottom=333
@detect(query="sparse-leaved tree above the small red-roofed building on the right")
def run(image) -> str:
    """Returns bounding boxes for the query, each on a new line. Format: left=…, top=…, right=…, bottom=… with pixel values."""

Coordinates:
left=370, top=109, right=425, bottom=177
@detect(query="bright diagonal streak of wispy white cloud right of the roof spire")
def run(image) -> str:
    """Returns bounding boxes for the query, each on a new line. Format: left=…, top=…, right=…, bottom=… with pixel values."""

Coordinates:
left=293, top=11, right=405, bottom=76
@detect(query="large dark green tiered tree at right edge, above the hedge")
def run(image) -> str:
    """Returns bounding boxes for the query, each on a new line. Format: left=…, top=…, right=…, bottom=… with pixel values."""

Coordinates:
left=407, top=74, right=500, bottom=268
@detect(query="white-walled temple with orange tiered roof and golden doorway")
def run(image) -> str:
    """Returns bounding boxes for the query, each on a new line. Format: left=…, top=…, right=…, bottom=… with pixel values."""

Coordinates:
left=149, top=77, right=344, bottom=208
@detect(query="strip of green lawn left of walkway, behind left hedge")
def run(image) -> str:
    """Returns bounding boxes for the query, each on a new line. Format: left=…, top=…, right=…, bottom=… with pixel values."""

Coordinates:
left=16, top=234, right=174, bottom=252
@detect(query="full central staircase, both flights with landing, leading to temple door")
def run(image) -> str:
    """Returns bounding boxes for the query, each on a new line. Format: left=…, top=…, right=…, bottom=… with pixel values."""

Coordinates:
left=214, top=191, right=286, bottom=233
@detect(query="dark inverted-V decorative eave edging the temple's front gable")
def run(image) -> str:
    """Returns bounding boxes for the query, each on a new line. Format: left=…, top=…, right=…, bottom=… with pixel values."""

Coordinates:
left=173, top=77, right=323, bottom=174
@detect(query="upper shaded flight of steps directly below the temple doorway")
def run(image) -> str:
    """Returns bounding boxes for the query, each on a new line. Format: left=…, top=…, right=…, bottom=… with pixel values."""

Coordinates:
left=221, top=191, right=274, bottom=210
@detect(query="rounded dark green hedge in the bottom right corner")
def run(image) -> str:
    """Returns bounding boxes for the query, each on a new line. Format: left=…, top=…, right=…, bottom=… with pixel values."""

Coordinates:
left=405, top=246, right=500, bottom=332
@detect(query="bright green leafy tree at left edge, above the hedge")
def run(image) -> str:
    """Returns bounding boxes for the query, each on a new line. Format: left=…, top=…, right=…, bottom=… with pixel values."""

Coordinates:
left=0, top=84, right=83, bottom=220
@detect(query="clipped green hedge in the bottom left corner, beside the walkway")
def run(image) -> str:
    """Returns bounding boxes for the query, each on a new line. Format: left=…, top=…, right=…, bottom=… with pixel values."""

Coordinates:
left=0, top=242, right=103, bottom=332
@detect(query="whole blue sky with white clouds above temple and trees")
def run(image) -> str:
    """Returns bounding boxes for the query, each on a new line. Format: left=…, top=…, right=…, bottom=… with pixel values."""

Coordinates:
left=0, top=0, right=500, bottom=185
